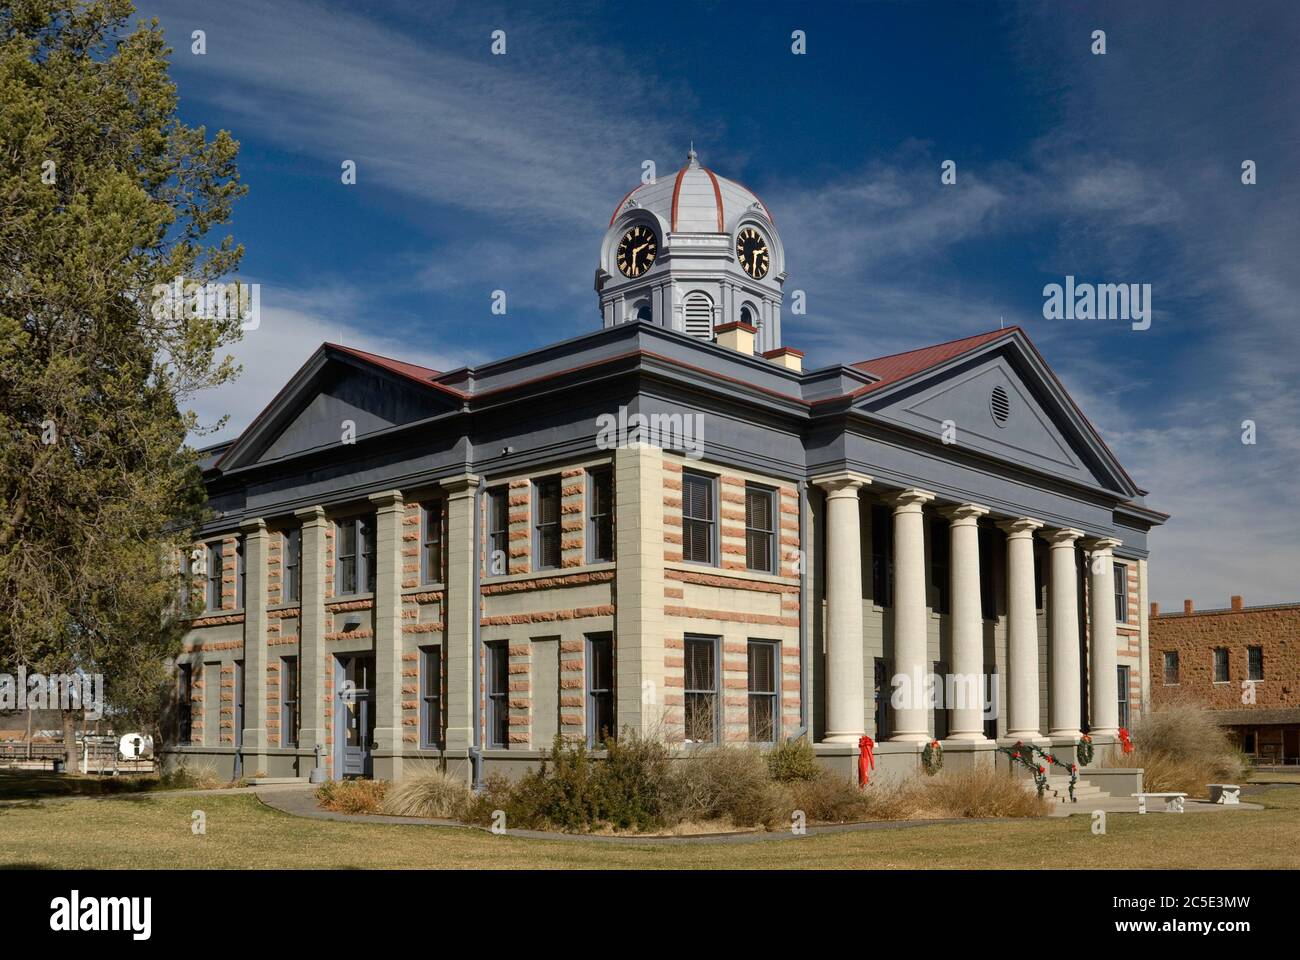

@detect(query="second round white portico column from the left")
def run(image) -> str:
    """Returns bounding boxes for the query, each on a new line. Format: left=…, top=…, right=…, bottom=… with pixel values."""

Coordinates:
left=889, top=489, right=935, bottom=743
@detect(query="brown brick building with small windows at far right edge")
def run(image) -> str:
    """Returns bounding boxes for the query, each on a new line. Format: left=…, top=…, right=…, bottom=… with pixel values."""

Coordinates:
left=1149, top=597, right=1300, bottom=764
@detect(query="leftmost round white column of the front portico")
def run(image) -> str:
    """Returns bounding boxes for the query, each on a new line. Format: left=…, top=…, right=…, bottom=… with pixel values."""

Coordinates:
left=813, top=472, right=871, bottom=744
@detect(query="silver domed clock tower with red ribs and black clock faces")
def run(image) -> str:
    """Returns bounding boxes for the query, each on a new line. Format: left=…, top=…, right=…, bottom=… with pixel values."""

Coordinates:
left=595, top=148, right=785, bottom=353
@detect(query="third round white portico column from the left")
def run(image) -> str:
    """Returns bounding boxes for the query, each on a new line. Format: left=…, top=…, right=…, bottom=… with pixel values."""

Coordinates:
left=943, top=503, right=988, bottom=740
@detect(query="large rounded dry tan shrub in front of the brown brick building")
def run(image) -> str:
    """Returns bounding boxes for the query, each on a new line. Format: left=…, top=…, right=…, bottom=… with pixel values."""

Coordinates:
left=1112, top=702, right=1248, bottom=796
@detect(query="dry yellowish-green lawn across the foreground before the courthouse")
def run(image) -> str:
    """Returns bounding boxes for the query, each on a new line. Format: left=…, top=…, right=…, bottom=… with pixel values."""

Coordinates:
left=0, top=786, right=1300, bottom=869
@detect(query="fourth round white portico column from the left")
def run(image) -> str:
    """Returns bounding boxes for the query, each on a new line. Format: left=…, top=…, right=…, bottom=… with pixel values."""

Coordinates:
left=997, top=516, right=1043, bottom=740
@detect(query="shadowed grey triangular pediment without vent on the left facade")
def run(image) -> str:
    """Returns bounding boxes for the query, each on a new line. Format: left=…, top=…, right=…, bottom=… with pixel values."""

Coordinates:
left=220, top=347, right=455, bottom=471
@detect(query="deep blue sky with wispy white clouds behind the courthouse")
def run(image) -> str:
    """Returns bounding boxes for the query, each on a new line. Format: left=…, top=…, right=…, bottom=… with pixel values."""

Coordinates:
left=139, top=0, right=1300, bottom=607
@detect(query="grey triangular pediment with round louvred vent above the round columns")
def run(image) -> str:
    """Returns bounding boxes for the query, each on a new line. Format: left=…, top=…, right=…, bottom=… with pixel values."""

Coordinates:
left=857, top=333, right=1138, bottom=497
